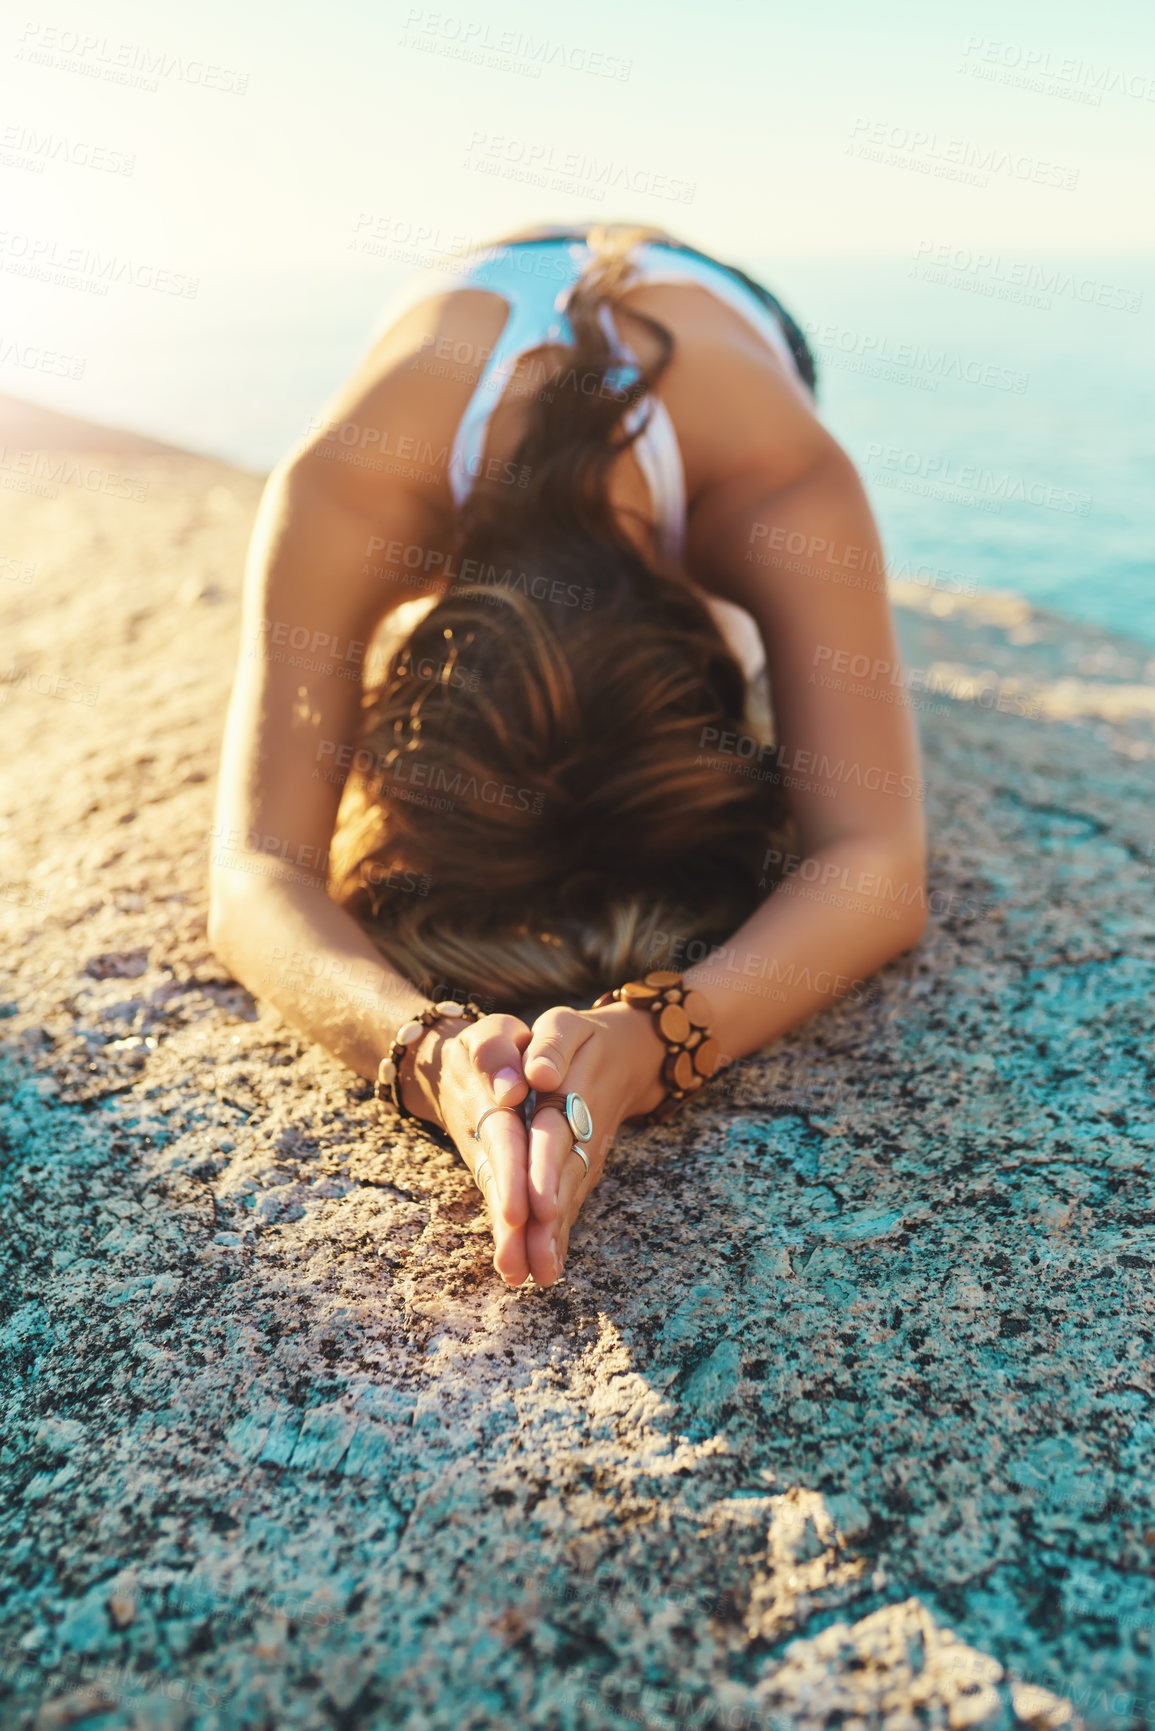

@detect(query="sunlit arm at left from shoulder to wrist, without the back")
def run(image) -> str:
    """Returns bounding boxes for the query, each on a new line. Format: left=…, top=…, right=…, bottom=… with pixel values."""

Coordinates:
left=210, top=448, right=436, bottom=1077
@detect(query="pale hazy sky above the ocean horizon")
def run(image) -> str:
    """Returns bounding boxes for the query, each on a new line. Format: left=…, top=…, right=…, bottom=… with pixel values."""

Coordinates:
left=0, top=0, right=1155, bottom=453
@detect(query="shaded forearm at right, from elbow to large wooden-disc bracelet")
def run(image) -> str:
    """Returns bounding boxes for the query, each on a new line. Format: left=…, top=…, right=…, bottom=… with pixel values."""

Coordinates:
left=678, top=840, right=926, bottom=1058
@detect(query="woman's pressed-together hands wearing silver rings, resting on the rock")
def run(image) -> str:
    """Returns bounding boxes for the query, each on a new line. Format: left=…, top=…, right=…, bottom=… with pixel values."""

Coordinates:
left=403, top=1004, right=663, bottom=1286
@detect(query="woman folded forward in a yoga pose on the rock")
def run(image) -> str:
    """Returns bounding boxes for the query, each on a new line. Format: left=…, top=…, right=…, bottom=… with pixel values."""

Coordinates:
left=210, top=227, right=925, bottom=1286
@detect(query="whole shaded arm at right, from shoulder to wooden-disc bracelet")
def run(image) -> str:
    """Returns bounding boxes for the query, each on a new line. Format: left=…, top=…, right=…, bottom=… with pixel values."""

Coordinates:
left=682, top=432, right=926, bottom=1058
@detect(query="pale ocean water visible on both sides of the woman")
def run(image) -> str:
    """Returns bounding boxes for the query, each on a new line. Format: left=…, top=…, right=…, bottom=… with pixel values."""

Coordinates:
left=36, top=242, right=1155, bottom=644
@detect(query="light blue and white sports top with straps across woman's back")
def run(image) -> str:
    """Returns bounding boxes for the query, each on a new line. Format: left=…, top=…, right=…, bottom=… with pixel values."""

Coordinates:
left=374, top=235, right=805, bottom=561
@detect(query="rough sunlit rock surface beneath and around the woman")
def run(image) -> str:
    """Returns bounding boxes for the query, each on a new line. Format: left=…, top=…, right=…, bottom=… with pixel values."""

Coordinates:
left=0, top=398, right=1155, bottom=1731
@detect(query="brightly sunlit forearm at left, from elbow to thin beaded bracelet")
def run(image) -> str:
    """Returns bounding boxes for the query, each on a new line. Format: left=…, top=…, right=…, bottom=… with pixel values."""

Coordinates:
left=210, top=879, right=426, bottom=1077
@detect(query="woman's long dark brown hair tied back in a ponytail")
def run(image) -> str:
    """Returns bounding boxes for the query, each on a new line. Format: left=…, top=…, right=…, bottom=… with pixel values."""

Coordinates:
left=331, top=237, right=784, bottom=1011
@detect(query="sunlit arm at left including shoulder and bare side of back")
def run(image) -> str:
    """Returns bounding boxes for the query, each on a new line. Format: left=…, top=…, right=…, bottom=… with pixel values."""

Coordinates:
left=210, top=294, right=516, bottom=1077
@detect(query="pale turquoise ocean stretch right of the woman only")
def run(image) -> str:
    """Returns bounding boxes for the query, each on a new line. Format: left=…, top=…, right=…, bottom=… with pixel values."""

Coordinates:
left=762, top=249, right=1155, bottom=644
